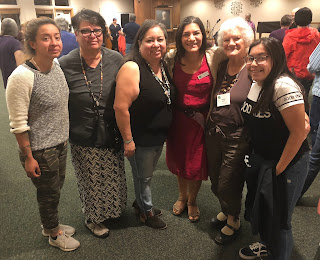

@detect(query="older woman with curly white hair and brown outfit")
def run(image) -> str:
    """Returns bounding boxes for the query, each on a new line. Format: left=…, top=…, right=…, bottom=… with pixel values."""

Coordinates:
left=206, top=17, right=253, bottom=245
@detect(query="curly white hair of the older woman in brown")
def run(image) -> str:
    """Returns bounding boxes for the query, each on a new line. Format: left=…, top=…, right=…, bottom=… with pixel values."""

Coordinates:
left=217, top=17, right=253, bottom=47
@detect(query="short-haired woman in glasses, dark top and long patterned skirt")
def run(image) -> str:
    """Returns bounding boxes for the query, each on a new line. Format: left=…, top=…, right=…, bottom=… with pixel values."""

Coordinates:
left=59, top=9, right=127, bottom=238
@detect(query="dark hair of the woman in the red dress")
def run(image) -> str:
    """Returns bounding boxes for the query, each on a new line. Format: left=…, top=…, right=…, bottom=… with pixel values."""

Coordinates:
left=176, top=16, right=207, bottom=61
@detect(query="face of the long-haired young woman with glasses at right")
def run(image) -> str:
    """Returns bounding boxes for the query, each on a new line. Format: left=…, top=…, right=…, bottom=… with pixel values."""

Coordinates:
left=247, top=44, right=272, bottom=86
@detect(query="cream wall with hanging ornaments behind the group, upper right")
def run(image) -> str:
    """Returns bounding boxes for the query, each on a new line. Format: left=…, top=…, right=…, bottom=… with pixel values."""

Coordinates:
left=180, top=0, right=320, bottom=35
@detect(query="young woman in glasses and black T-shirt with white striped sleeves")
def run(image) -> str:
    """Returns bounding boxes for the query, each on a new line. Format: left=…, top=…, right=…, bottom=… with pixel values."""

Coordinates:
left=239, top=37, right=309, bottom=260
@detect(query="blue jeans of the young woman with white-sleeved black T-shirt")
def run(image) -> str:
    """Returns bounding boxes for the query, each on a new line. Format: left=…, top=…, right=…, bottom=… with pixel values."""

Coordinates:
left=274, top=152, right=309, bottom=260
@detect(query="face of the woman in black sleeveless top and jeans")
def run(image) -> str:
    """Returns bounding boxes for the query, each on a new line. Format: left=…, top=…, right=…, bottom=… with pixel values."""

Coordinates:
left=139, top=26, right=167, bottom=64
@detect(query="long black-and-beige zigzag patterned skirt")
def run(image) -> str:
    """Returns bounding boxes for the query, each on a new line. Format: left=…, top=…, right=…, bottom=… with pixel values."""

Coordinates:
left=70, top=144, right=127, bottom=223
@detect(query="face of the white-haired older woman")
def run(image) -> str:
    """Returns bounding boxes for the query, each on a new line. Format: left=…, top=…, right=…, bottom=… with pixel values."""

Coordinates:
left=223, top=28, right=247, bottom=59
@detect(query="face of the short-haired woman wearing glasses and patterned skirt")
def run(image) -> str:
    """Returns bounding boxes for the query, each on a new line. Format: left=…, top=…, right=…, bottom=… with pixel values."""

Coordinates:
left=76, top=21, right=103, bottom=52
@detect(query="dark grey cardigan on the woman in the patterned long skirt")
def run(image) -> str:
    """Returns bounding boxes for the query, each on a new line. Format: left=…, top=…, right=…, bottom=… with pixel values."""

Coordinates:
left=59, top=47, right=123, bottom=147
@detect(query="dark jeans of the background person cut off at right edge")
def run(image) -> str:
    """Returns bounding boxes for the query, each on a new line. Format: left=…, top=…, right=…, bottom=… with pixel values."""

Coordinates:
left=301, top=123, right=320, bottom=197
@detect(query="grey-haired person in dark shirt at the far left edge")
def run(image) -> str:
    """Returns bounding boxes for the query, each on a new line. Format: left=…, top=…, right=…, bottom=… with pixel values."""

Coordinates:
left=0, top=18, right=24, bottom=88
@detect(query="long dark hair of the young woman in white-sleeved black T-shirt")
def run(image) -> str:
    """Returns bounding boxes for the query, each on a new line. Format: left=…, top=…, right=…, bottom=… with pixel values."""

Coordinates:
left=249, top=37, right=303, bottom=113
